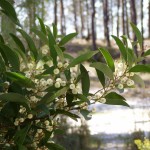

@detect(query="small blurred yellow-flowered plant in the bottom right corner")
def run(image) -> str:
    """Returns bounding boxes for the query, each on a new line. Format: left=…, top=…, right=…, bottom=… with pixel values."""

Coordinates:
left=134, top=139, right=150, bottom=150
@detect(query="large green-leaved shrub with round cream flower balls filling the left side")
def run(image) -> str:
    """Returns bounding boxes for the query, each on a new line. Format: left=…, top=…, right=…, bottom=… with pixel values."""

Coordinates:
left=0, top=0, right=150, bottom=150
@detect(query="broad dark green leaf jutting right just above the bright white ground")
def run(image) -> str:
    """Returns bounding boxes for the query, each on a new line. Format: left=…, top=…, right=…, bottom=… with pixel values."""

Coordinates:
left=105, top=92, right=130, bottom=107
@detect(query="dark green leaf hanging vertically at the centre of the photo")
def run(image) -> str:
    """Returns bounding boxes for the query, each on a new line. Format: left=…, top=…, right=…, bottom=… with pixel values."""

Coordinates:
left=80, top=64, right=90, bottom=96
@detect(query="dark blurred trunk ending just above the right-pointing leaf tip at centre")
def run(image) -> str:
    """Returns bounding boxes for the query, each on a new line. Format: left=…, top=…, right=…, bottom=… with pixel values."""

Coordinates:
left=91, top=0, right=97, bottom=50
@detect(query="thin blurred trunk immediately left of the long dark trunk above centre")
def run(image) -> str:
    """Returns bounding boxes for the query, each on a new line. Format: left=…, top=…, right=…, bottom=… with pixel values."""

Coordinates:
left=86, top=0, right=90, bottom=40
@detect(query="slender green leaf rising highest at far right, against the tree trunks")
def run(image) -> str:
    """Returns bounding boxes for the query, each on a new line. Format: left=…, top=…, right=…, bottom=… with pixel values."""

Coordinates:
left=130, top=22, right=143, bottom=48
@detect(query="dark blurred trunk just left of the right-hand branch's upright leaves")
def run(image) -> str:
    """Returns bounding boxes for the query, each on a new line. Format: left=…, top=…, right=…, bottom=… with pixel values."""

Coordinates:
left=103, top=0, right=110, bottom=46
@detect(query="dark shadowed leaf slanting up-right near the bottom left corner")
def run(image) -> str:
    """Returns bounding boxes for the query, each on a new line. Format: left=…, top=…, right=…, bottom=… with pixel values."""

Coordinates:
left=14, top=124, right=31, bottom=145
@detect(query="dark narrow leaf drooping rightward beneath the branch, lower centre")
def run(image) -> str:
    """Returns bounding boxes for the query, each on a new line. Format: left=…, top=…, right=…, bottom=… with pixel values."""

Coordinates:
left=55, top=109, right=80, bottom=121
